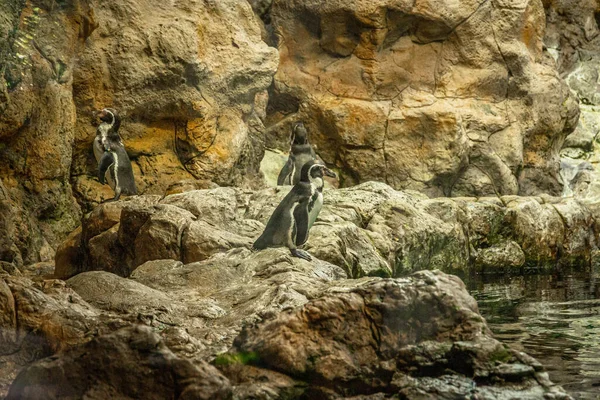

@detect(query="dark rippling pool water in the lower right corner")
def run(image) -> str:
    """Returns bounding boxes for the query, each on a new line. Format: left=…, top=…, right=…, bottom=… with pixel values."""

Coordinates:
left=465, top=273, right=600, bottom=400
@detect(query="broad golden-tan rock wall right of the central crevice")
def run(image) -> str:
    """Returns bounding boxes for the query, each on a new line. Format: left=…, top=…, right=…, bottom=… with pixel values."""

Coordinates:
left=264, top=0, right=578, bottom=196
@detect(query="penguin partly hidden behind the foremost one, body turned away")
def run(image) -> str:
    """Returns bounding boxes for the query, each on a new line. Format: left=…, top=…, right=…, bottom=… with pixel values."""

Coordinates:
left=277, top=122, right=317, bottom=186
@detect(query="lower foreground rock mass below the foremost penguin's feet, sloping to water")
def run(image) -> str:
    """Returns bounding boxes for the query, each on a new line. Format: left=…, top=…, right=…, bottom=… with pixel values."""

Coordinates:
left=0, top=270, right=570, bottom=399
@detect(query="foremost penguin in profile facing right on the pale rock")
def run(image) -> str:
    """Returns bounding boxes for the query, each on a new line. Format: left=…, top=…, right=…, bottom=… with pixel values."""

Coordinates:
left=252, top=160, right=336, bottom=261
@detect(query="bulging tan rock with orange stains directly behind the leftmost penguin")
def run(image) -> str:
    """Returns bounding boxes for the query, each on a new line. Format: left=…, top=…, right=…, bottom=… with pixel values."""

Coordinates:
left=73, top=0, right=277, bottom=206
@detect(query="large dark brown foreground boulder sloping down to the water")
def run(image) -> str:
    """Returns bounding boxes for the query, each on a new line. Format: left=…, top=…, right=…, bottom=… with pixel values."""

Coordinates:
left=223, top=271, right=570, bottom=399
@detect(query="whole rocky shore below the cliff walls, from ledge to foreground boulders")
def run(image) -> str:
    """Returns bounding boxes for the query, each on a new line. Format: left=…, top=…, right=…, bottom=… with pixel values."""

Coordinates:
left=0, top=182, right=597, bottom=399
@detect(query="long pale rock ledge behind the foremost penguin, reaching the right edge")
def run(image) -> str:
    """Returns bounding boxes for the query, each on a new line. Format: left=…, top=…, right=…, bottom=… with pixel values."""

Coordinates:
left=55, top=182, right=600, bottom=279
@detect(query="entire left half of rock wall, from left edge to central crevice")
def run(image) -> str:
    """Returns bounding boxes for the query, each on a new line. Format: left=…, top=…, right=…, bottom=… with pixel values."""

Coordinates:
left=0, top=0, right=277, bottom=265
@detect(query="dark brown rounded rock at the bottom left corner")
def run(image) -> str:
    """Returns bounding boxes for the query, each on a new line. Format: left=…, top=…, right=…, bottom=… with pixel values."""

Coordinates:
left=7, top=326, right=231, bottom=400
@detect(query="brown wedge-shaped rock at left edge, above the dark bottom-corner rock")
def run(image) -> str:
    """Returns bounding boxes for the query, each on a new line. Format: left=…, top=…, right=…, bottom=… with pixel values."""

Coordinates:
left=0, top=275, right=113, bottom=396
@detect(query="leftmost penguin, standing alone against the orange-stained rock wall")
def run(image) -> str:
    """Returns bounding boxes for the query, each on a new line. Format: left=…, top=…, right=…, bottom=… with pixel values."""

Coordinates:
left=93, top=108, right=137, bottom=201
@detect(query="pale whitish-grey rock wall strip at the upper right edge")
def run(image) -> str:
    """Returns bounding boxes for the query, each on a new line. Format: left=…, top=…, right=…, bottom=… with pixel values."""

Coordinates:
left=544, top=0, right=600, bottom=202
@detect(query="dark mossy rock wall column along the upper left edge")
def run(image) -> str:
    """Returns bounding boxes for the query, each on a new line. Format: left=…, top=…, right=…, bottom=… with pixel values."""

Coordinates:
left=0, top=1, right=92, bottom=265
